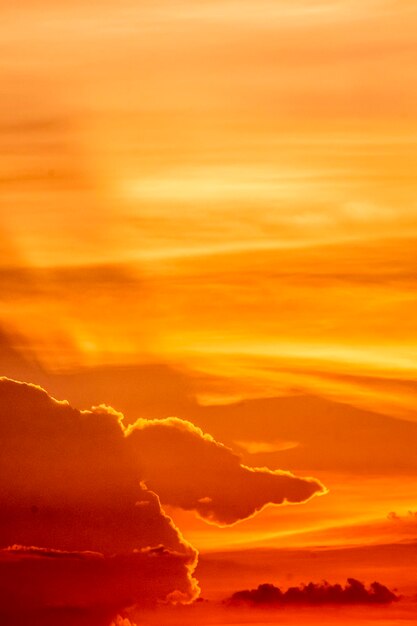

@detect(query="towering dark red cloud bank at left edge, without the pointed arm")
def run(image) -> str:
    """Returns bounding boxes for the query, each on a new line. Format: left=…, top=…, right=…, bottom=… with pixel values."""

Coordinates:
left=0, top=372, right=198, bottom=626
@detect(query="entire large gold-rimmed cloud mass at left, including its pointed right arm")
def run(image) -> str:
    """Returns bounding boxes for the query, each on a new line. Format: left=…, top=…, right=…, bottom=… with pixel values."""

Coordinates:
left=0, top=378, right=324, bottom=626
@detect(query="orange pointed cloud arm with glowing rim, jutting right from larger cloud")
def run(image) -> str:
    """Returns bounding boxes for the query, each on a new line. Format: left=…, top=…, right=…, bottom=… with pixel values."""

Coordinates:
left=126, top=418, right=325, bottom=525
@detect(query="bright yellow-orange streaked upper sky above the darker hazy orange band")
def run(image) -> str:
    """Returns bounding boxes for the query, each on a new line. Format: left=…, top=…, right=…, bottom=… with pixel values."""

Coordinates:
left=0, top=0, right=417, bottom=408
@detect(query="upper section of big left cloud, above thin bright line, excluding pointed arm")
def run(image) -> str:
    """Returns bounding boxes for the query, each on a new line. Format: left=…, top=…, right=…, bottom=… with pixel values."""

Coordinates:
left=0, top=379, right=195, bottom=554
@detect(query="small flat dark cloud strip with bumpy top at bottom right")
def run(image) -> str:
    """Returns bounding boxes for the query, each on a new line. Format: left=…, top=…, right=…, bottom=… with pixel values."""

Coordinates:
left=226, top=578, right=399, bottom=607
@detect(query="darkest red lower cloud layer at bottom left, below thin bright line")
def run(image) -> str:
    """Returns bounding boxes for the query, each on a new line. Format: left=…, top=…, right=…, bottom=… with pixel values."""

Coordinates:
left=0, top=546, right=190, bottom=626
